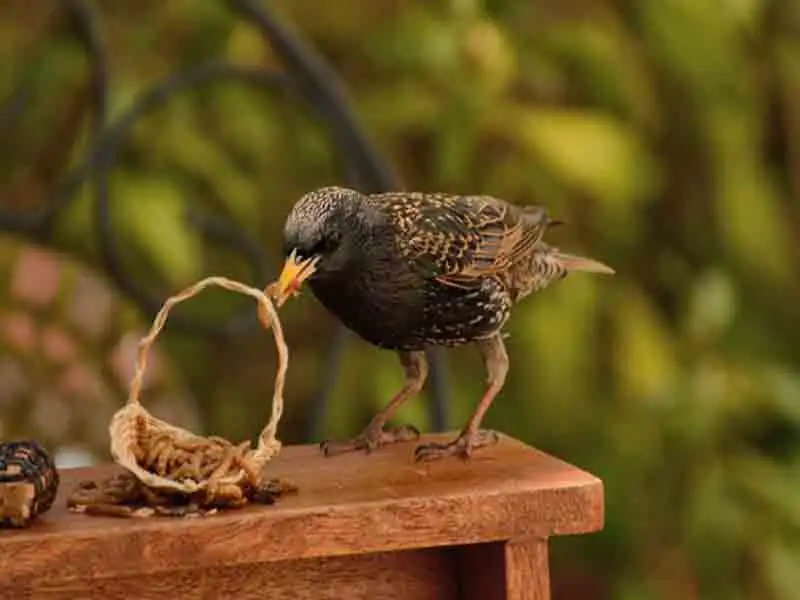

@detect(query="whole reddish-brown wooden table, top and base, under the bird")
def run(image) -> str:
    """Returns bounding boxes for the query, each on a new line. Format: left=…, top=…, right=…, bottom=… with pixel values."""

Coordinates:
left=0, top=436, right=603, bottom=600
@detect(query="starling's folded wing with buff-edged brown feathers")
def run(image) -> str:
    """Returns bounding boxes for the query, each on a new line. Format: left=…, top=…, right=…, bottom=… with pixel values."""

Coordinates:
left=374, top=193, right=551, bottom=287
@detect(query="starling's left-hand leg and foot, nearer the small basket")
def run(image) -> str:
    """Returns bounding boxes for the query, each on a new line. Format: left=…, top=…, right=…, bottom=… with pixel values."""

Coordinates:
left=320, top=351, right=428, bottom=456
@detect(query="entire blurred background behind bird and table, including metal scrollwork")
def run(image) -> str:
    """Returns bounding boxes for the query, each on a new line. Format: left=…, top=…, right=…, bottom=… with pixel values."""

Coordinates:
left=0, top=0, right=800, bottom=600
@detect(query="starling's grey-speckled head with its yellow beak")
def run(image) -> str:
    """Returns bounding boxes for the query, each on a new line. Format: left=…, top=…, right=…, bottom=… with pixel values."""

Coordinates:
left=273, top=187, right=362, bottom=305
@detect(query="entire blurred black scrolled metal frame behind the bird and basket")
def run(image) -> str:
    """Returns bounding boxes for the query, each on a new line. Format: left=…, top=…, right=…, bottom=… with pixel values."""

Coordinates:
left=0, top=0, right=447, bottom=439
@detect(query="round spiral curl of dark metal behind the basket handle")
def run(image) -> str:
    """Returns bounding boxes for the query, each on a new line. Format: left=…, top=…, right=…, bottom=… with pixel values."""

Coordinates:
left=89, top=61, right=287, bottom=335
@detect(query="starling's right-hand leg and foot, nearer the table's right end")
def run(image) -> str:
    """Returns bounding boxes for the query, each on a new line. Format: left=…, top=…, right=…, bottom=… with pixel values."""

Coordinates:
left=414, top=332, right=508, bottom=461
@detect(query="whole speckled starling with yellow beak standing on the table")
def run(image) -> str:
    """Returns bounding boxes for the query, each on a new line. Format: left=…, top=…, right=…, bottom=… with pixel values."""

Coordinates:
left=273, top=187, right=614, bottom=460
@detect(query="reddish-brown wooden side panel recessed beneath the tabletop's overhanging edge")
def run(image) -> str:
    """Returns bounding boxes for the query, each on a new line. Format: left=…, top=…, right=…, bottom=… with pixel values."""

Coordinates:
left=18, top=548, right=459, bottom=600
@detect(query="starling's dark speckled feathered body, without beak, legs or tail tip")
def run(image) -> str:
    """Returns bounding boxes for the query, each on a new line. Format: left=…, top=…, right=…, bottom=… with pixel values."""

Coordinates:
left=286, top=188, right=604, bottom=350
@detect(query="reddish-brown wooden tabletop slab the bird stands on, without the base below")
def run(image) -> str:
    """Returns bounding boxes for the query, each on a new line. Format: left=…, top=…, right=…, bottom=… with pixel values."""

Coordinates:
left=0, top=434, right=603, bottom=580
